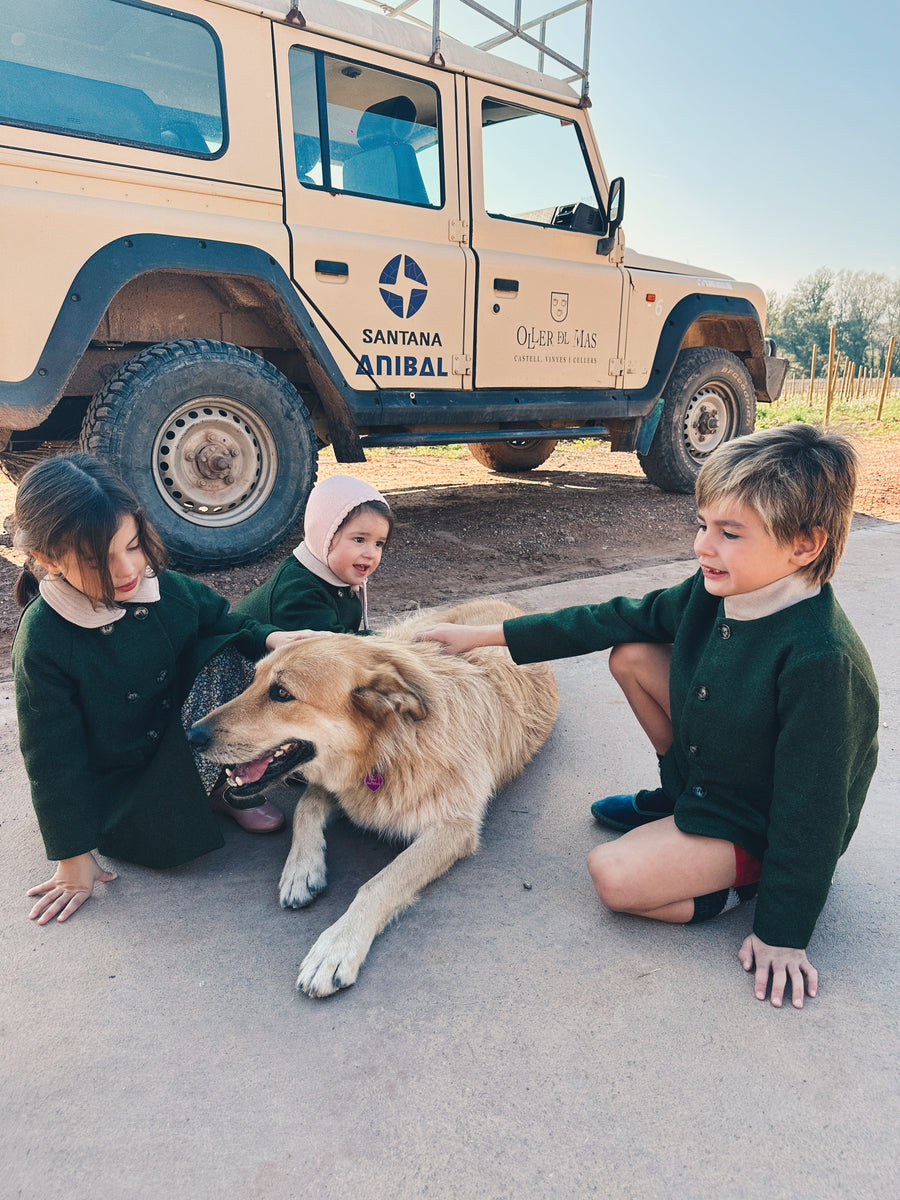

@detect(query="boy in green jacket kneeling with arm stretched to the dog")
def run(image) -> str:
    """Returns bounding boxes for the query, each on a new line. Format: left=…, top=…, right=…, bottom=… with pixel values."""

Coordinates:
left=425, top=424, right=878, bottom=1008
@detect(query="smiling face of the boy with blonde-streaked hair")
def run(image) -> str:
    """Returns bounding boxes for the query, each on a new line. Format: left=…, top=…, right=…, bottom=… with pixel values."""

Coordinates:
left=694, top=498, right=815, bottom=596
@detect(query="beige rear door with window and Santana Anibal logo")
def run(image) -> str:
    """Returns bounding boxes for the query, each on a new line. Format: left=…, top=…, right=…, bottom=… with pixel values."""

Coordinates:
left=275, top=26, right=473, bottom=394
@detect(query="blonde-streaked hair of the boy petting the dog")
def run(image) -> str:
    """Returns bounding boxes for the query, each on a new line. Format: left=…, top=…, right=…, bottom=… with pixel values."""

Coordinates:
left=695, top=422, right=858, bottom=584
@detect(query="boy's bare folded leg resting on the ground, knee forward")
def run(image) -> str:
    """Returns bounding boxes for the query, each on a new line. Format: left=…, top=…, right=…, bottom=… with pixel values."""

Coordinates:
left=588, top=817, right=737, bottom=924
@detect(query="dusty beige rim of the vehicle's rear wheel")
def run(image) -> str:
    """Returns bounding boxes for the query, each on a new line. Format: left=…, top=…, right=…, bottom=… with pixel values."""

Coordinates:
left=152, top=396, right=278, bottom=526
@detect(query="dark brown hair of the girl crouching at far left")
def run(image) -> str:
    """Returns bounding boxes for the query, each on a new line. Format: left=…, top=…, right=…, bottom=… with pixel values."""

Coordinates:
left=13, top=454, right=166, bottom=608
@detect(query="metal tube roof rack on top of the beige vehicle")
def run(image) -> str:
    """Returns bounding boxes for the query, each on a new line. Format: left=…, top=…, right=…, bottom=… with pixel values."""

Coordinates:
left=352, top=0, right=593, bottom=108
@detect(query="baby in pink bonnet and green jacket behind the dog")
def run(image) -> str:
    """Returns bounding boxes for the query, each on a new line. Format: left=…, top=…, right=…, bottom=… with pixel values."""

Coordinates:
left=234, top=475, right=394, bottom=634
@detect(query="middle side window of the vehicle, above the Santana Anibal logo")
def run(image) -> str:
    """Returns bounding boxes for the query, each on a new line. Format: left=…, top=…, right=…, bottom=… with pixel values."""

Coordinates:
left=289, top=46, right=443, bottom=208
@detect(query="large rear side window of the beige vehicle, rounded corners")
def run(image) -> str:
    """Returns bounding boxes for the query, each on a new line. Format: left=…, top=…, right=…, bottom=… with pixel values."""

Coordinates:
left=0, top=0, right=224, bottom=157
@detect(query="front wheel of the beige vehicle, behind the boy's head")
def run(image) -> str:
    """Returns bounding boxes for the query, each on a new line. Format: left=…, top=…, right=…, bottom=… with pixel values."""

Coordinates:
left=637, top=347, right=756, bottom=492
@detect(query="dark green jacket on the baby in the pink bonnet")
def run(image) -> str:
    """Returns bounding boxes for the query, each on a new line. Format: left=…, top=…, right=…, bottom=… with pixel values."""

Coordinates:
left=233, top=554, right=362, bottom=634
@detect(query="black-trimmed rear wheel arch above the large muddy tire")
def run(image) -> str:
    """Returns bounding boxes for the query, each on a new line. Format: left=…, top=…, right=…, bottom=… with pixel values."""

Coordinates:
left=0, top=234, right=365, bottom=462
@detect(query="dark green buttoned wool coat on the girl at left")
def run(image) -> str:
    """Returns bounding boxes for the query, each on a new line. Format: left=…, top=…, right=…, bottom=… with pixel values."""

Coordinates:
left=12, top=571, right=274, bottom=866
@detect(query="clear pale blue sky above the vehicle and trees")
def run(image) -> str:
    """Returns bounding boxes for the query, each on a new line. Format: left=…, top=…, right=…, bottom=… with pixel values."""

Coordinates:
left=348, top=0, right=900, bottom=295
